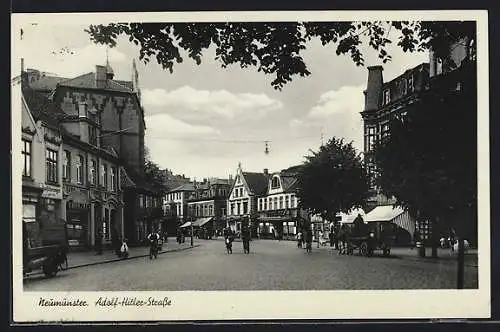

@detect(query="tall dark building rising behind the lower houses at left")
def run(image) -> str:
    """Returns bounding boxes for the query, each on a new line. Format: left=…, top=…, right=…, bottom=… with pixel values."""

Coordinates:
left=28, top=62, right=162, bottom=244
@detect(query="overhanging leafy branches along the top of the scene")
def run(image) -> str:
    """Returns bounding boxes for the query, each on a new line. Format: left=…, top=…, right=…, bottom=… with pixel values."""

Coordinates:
left=86, top=21, right=475, bottom=90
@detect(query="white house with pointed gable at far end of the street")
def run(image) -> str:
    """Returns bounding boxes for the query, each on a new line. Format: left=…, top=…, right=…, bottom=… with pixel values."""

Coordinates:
left=227, top=163, right=269, bottom=236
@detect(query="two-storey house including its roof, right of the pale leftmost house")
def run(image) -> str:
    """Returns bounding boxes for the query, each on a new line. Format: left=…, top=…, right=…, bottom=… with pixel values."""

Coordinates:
left=23, top=66, right=123, bottom=248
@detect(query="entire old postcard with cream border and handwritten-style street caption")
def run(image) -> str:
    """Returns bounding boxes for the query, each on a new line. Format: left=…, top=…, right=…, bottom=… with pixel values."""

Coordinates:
left=11, top=11, right=490, bottom=322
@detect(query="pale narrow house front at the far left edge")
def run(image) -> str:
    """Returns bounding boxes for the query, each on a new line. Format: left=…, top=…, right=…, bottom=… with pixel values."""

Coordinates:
left=19, top=75, right=65, bottom=247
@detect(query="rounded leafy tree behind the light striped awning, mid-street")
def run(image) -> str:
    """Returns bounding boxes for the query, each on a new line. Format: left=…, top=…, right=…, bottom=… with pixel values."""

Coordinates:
left=297, top=137, right=369, bottom=221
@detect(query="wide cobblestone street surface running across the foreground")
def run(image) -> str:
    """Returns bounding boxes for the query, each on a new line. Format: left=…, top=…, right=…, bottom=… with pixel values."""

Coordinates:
left=24, top=240, right=478, bottom=291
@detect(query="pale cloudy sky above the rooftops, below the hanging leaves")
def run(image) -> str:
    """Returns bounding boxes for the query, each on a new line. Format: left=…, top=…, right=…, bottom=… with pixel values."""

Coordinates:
left=17, top=24, right=428, bottom=179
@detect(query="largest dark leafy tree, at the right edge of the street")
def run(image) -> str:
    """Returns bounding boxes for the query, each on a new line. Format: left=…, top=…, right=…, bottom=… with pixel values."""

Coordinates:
left=375, top=63, right=478, bottom=256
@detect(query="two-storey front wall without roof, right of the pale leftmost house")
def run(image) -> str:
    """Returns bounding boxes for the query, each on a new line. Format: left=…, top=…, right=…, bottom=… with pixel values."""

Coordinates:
left=62, top=133, right=124, bottom=248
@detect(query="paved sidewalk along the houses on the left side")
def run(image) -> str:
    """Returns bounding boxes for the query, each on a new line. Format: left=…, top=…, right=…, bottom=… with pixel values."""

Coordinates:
left=68, top=241, right=199, bottom=269
